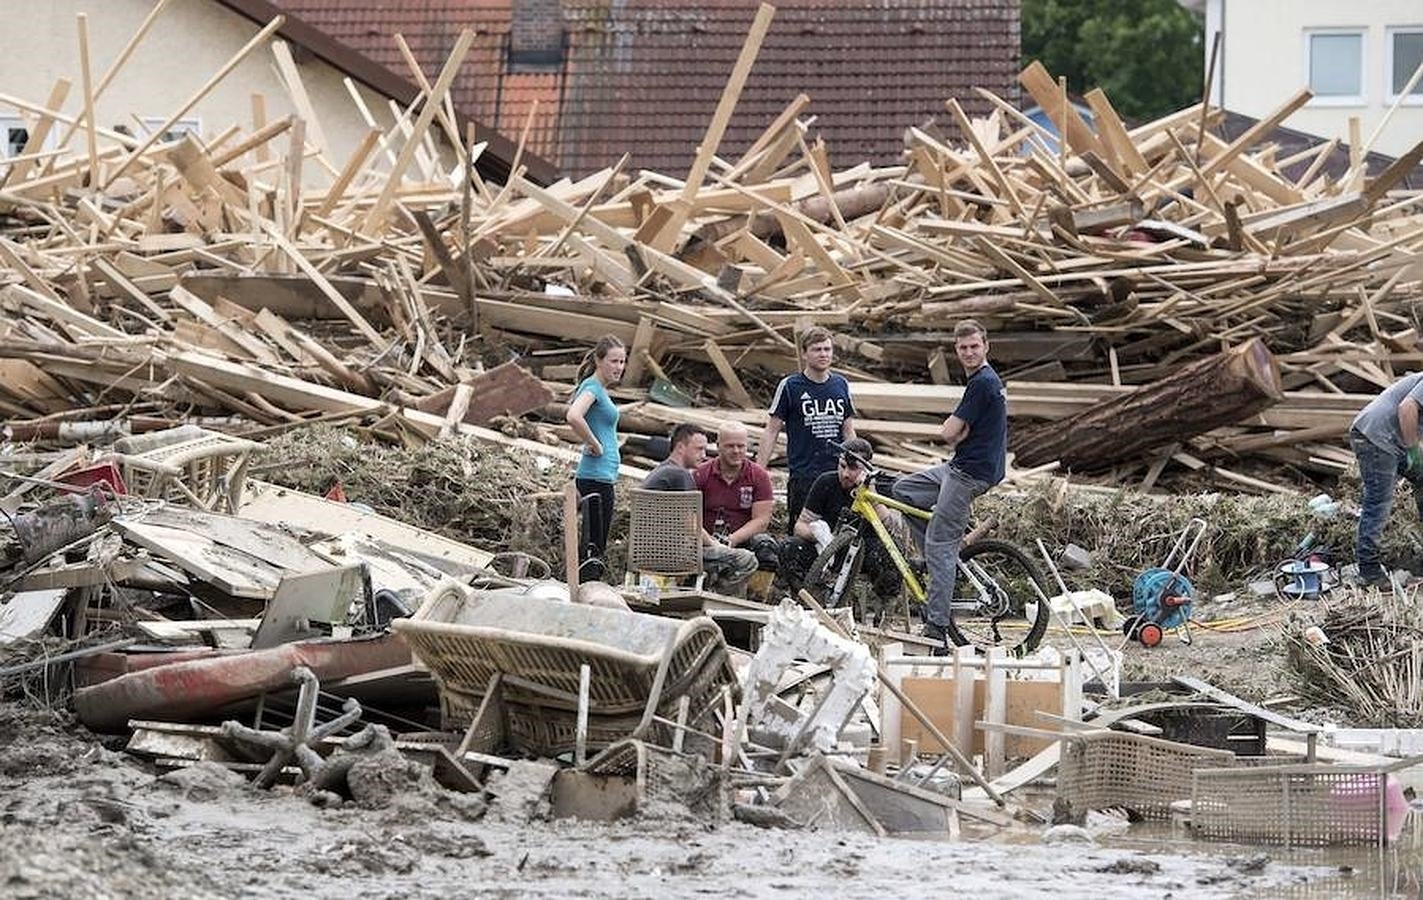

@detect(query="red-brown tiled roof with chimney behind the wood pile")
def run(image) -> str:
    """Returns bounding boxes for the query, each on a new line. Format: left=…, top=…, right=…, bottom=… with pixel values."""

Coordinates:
left=268, top=0, right=1019, bottom=175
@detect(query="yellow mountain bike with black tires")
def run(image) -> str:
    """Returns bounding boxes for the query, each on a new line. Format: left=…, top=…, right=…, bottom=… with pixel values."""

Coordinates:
left=804, top=444, right=1050, bottom=656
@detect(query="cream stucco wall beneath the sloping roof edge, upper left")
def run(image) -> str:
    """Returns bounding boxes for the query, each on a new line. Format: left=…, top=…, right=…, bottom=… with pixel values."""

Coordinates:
left=0, top=0, right=451, bottom=187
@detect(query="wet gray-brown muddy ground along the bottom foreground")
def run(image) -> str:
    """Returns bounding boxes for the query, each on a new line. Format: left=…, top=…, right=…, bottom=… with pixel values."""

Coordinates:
left=0, top=706, right=1339, bottom=900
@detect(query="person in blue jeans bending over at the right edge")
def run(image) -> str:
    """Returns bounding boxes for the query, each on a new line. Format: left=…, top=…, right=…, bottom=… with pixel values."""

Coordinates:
left=1349, top=372, right=1423, bottom=587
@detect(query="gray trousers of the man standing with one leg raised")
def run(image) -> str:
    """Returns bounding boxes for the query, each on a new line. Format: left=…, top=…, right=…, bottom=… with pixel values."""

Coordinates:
left=894, top=463, right=990, bottom=628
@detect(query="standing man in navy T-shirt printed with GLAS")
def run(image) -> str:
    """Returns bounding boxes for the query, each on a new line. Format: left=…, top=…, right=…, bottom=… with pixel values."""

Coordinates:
left=756, top=328, right=855, bottom=528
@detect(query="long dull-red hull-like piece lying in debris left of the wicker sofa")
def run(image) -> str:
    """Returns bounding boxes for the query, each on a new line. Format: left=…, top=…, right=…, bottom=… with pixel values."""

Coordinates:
left=74, top=634, right=410, bottom=733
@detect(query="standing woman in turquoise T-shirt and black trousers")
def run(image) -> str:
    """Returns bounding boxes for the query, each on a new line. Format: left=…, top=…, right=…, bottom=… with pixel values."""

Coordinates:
left=564, top=335, right=628, bottom=580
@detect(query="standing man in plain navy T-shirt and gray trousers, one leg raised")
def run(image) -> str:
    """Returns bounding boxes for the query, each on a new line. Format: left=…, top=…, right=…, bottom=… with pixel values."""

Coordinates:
left=894, top=319, right=1007, bottom=654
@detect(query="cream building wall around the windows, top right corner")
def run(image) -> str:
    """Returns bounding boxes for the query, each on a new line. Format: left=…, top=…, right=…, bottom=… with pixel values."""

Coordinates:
left=1205, top=0, right=1423, bottom=155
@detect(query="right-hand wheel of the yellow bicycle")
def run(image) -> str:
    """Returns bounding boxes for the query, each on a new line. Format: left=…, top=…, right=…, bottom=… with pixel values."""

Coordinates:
left=949, top=540, right=1049, bottom=656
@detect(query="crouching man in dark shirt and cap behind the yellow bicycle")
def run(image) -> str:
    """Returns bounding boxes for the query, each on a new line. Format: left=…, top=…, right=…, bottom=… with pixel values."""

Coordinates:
left=777, top=437, right=901, bottom=600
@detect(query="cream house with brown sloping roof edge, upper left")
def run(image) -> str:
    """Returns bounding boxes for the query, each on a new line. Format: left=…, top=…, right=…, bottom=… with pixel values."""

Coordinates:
left=0, top=0, right=554, bottom=187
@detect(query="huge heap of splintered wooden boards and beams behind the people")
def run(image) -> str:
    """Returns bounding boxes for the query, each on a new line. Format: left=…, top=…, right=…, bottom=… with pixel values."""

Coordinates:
left=0, top=21, right=1423, bottom=490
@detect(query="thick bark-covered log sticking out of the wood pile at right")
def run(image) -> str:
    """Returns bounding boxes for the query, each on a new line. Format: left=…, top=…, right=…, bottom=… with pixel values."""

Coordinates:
left=1009, top=338, right=1282, bottom=473
